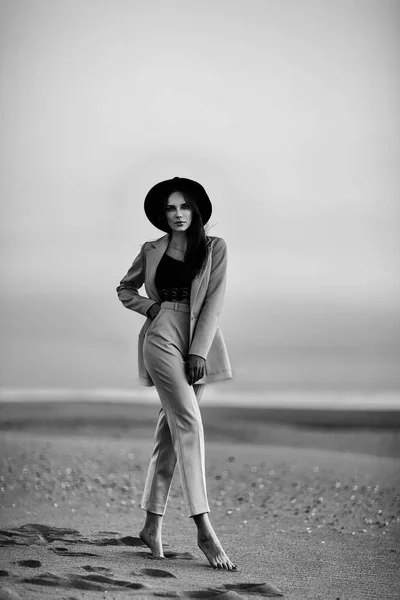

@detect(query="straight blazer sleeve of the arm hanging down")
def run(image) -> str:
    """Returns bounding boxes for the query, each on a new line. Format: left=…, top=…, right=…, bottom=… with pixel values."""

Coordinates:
left=189, top=238, right=228, bottom=359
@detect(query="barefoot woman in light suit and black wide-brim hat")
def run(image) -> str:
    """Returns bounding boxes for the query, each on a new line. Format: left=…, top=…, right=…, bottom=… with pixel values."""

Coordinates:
left=117, top=177, right=236, bottom=570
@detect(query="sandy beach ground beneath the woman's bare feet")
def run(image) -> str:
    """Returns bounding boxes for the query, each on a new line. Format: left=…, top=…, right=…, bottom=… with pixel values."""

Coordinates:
left=0, top=403, right=400, bottom=600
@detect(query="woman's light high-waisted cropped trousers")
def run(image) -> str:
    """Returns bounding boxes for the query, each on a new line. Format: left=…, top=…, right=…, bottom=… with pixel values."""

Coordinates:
left=141, top=302, right=210, bottom=516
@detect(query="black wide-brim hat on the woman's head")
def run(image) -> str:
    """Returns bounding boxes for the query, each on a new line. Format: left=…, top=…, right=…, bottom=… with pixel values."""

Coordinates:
left=144, top=177, right=212, bottom=233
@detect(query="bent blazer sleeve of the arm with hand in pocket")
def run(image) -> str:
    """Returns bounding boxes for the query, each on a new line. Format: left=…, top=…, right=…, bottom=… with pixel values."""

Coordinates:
left=117, top=243, right=157, bottom=316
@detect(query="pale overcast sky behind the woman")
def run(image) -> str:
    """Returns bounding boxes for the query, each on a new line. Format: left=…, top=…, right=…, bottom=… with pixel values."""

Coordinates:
left=0, top=0, right=400, bottom=400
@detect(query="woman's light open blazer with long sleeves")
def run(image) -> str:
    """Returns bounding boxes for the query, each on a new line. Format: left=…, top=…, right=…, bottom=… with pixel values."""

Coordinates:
left=117, top=235, right=232, bottom=386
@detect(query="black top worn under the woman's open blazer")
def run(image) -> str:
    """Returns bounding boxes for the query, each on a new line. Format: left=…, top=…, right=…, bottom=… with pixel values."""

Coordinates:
left=155, top=252, right=193, bottom=302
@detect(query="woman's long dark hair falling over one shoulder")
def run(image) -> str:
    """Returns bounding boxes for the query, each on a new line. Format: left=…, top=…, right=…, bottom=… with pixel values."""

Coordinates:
left=160, top=188, right=208, bottom=279
